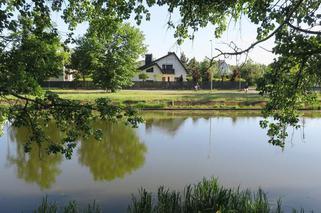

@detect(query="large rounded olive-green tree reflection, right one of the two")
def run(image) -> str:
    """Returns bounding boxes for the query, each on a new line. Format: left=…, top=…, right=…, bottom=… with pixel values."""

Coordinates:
left=78, top=122, right=147, bottom=180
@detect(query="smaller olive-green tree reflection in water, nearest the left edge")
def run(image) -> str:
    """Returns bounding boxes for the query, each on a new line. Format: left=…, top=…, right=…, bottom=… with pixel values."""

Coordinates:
left=8, top=125, right=63, bottom=189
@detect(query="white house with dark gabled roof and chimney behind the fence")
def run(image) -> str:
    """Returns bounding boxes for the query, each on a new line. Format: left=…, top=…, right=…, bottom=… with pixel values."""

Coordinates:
left=133, top=52, right=187, bottom=82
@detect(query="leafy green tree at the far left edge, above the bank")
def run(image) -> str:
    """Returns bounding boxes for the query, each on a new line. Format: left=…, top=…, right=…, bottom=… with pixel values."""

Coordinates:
left=0, top=17, right=69, bottom=95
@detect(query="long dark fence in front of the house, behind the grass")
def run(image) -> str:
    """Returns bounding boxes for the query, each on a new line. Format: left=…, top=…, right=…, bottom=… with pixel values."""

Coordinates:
left=41, top=81, right=245, bottom=90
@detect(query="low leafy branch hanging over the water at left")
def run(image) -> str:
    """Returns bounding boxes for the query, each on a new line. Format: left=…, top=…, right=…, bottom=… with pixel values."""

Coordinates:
left=3, top=92, right=142, bottom=158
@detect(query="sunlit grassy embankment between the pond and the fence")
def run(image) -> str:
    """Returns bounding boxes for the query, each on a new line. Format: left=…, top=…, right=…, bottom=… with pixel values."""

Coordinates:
left=48, top=90, right=321, bottom=110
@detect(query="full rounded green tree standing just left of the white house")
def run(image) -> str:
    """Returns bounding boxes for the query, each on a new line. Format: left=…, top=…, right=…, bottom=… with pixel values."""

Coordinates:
left=72, top=19, right=146, bottom=91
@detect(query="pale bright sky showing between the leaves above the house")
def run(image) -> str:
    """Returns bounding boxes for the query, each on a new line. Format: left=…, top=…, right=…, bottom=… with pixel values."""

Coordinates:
left=52, top=6, right=275, bottom=64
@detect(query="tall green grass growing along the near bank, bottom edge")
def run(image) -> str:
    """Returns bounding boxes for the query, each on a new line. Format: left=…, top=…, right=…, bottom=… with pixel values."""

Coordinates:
left=34, top=178, right=305, bottom=213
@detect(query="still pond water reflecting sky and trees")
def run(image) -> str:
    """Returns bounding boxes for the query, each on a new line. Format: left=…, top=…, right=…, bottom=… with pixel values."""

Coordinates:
left=0, top=112, right=321, bottom=212
